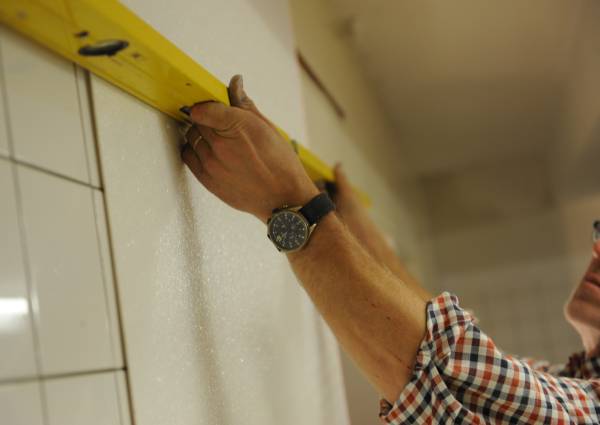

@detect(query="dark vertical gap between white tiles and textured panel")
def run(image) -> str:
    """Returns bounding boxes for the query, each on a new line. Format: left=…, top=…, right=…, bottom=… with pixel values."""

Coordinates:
left=85, top=71, right=136, bottom=425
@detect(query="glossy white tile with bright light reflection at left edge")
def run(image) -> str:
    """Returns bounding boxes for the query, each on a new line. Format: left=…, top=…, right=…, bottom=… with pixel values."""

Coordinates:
left=0, top=159, right=36, bottom=379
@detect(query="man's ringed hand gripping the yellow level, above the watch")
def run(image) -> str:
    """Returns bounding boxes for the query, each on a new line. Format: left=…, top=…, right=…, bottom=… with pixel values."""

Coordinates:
left=181, top=75, right=319, bottom=222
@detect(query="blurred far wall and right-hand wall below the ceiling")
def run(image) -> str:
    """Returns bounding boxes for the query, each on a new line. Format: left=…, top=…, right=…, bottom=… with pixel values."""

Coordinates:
left=429, top=1, right=600, bottom=362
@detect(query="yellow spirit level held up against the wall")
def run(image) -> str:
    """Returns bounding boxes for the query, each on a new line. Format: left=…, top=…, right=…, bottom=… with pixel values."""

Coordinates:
left=0, top=0, right=371, bottom=206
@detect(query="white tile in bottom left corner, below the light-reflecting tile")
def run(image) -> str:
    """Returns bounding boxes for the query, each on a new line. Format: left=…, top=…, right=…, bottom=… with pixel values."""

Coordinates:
left=0, top=382, right=43, bottom=425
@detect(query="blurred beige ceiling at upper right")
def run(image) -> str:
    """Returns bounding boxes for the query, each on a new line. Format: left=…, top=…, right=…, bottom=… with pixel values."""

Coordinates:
left=331, top=0, right=581, bottom=178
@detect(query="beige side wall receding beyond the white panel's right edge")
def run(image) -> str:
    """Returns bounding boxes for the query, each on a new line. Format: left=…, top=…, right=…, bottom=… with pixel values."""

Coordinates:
left=291, top=0, right=430, bottom=425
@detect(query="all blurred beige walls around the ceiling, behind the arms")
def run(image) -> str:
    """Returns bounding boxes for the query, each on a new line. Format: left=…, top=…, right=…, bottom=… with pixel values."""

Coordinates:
left=291, top=0, right=600, bottom=424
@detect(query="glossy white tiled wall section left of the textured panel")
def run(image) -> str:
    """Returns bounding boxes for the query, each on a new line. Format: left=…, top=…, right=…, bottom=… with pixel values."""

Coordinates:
left=0, top=25, right=131, bottom=425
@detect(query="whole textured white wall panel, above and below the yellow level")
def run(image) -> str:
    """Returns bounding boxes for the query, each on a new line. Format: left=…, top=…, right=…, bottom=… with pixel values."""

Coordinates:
left=92, top=0, right=348, bottom=425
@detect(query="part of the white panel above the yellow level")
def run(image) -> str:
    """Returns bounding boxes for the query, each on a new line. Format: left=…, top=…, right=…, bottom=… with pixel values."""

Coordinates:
left=122, top=0, right=306, bottom=142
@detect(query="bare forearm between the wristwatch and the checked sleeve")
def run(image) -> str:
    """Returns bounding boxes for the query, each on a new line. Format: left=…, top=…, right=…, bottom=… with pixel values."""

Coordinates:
left=288, top=214, right=425, bottom=400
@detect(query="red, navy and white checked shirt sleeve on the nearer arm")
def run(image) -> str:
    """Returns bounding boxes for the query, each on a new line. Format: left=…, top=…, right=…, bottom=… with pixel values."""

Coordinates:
left=380, top=293, right=600, bottom=425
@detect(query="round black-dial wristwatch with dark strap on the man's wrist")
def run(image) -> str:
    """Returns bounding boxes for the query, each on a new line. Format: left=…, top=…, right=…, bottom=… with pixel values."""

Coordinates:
left=267, top=192, right=335, bottom=252
